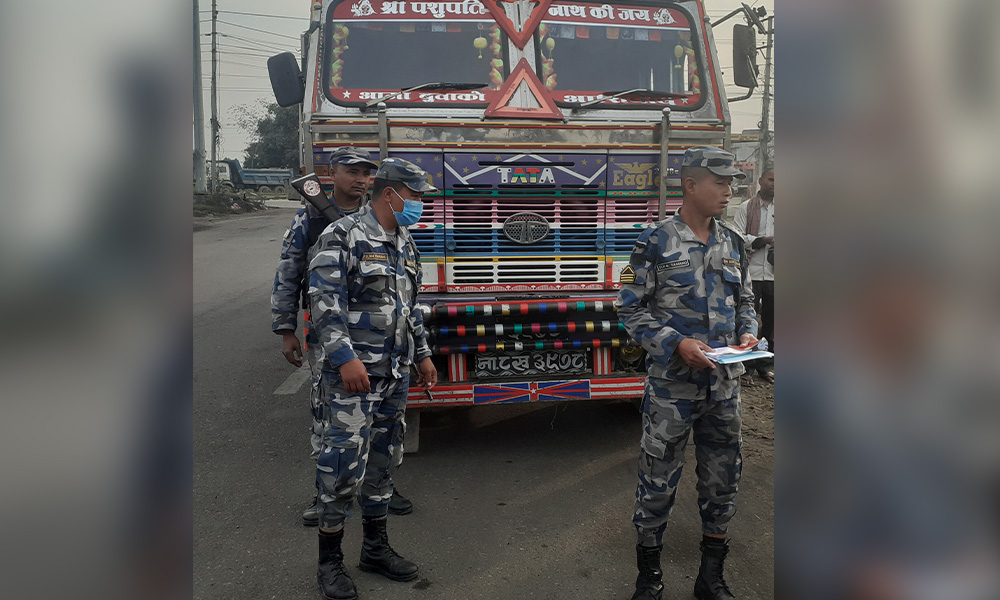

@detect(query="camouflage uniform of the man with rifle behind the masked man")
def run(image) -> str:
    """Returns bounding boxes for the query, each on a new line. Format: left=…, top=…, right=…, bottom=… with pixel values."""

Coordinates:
left=271, top=147, right=374, bottom=458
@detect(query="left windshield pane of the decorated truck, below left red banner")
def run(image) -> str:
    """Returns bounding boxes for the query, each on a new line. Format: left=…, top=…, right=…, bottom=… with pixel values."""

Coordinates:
left=324, top=0, right=509, bottom=106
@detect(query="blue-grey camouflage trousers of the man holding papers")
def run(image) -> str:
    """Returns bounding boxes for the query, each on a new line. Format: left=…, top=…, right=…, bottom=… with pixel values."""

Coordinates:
left=632, top=377, right=743, bottom=546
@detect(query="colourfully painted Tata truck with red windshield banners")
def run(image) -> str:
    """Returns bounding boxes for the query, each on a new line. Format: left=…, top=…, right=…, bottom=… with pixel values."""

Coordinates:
left=268, top=0, right=759, bottom=450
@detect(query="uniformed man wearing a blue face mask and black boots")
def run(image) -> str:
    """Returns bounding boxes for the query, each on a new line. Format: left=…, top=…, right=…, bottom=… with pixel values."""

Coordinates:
left=309, top=158, right=437, bottom=600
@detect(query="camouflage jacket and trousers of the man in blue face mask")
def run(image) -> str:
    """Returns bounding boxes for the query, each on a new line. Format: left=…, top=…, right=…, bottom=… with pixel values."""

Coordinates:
left=309, top=205, right=431, bottom=529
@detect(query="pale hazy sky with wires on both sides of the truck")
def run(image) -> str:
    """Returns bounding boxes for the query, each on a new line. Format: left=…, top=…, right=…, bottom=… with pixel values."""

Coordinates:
left=199, top=0, right=774, bottom=159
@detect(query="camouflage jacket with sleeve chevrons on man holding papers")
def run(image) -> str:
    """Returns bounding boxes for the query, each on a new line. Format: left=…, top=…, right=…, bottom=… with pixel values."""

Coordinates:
left=615, top=216, right=757, bottom=397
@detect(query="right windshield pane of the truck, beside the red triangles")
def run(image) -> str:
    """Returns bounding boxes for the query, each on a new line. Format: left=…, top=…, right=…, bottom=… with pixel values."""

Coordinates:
left=536, top=2, right=703, bottom=110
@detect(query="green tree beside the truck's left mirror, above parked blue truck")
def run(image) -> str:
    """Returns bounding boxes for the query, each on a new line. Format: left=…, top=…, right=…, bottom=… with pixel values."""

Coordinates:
left=230, top=100, right=299, bottom=170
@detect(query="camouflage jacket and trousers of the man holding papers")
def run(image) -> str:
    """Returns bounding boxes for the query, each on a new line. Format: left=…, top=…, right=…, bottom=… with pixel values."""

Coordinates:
left=616, top=159, right=757, bottom=547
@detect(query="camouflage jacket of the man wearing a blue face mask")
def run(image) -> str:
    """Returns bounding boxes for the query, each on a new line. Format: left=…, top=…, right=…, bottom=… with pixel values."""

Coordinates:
left=309, top=205, right=431, bottom=377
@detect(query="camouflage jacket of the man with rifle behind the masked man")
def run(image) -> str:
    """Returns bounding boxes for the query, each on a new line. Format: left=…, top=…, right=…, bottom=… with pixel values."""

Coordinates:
left=271, top=198, right=367, bottom=333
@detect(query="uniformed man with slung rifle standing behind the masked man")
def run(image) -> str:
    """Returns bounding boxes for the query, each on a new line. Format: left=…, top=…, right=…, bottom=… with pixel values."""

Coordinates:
left=271, top=146, right=413, bottom=527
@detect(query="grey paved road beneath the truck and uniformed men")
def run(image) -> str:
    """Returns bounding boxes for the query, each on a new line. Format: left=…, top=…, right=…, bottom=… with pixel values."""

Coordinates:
left=194, top=210, right=774, bottom=600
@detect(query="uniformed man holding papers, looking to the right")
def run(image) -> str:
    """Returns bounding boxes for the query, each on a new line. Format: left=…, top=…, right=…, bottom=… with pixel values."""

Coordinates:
left=615, top=146, right=757, bottom=600
